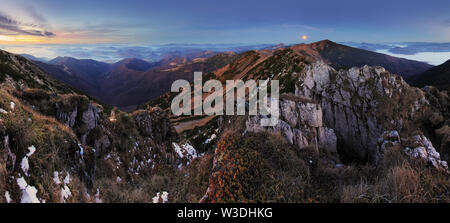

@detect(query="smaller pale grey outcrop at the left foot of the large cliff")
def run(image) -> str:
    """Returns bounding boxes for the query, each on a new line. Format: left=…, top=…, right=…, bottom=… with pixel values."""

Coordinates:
left=246, top=95, right=337, bottom=152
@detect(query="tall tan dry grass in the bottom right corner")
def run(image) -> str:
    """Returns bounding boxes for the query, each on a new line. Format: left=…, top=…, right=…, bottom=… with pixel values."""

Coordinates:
left=341, top=145, right=450, bottom=203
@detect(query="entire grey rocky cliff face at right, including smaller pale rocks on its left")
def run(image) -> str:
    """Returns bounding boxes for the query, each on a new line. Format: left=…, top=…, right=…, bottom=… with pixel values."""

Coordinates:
left=246, top=61, right=448, bottom=165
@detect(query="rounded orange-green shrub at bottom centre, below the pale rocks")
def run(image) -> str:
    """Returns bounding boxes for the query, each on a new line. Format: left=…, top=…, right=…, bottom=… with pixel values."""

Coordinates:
left=210, top=132, right=306, bottom=202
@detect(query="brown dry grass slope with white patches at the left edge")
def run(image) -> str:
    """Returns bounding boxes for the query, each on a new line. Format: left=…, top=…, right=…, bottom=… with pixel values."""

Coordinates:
left=0, top=89, right=84, bottom=203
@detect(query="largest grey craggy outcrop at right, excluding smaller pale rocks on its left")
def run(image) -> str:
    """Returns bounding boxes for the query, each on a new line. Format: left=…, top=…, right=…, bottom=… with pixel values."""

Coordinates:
left=295, top=61, right=438, bottom=161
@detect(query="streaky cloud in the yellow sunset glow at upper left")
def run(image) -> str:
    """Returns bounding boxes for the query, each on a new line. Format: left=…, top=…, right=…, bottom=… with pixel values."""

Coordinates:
left=0, top=12, right=55, bottom=37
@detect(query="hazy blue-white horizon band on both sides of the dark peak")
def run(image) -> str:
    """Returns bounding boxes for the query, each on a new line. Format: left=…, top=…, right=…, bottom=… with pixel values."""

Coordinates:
left=0, top=41, right=450, bottom=65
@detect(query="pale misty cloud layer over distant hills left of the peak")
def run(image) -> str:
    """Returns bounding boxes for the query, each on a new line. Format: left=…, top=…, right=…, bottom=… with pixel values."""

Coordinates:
left=0, top=44, right=273, bottom=62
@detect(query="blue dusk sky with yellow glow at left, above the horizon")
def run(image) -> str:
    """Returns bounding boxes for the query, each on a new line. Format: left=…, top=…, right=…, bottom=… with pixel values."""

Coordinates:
left=0, top=0, right=450, bottom=64
